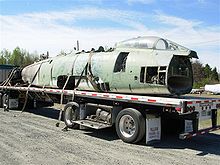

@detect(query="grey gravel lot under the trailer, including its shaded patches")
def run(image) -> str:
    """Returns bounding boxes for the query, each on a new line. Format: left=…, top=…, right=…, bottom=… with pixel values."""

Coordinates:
left=0, top=108, right=220, bottom=165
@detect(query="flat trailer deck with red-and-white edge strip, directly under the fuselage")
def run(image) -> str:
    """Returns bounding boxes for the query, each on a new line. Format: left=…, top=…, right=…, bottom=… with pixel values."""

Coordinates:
left=0, top=86, right=220, bottom=114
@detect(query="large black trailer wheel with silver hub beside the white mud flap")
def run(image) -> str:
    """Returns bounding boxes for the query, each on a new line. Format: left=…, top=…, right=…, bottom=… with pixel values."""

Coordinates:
left=115, top=108, right=145, bottom=143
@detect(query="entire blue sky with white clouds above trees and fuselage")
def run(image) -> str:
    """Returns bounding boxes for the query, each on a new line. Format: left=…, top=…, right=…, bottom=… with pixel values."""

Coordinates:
left=0, top=0, right=220, bottom=71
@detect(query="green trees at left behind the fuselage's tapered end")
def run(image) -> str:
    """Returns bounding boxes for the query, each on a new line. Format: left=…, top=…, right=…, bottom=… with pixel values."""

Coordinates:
left=0, top=47, right=39, bottom=67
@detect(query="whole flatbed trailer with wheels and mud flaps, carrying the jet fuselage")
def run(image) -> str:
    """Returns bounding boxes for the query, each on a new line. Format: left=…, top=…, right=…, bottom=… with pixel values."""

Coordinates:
left=0, top=86, right=220, bottom=143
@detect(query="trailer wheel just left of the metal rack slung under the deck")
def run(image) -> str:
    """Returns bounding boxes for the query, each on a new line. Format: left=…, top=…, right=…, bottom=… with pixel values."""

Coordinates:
left=64, top=102, right=79, bottom=129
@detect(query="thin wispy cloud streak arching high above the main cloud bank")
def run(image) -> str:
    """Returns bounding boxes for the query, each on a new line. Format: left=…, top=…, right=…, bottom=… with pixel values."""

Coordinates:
left=22, top=8, right=148, bottom=28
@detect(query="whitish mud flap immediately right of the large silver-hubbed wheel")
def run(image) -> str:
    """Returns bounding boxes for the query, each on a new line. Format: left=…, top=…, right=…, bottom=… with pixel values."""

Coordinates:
left=146, top=114, right=161, bottom=144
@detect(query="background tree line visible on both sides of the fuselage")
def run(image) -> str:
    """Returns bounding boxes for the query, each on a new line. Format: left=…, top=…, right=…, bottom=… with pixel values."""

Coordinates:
left=0, top=47, right=219, bottom=88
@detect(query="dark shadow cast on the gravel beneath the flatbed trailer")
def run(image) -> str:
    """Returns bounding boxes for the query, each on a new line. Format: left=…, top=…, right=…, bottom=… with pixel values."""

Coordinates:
left=18, top=107, right=220, bottom=156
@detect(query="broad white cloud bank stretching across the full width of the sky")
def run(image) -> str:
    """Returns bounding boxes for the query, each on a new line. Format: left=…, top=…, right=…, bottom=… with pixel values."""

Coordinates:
left=0, top=8, right=220, bottom=68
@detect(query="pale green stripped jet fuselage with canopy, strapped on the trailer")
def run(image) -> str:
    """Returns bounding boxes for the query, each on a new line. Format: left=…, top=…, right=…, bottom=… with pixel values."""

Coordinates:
left=22, top=37, right=198, bottom=95
